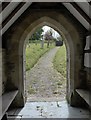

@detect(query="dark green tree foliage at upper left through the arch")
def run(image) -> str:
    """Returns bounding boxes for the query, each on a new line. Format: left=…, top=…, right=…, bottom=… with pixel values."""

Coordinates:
left=29, top=28, right=44, bottom=41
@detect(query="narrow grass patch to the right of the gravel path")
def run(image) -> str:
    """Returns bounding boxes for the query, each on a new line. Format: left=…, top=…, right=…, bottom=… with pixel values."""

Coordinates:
left=53, top=45, right=66, bottom=78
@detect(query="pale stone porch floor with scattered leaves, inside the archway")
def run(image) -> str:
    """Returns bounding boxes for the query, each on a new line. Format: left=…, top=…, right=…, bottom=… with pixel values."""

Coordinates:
left=8, top=101, right=89, bottom=120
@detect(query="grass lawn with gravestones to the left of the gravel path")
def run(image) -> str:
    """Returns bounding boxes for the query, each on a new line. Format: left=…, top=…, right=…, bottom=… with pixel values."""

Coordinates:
left=26, top=43, right=54, bottom=71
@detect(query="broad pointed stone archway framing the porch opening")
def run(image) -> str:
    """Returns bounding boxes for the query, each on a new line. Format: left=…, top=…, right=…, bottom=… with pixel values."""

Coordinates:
left=6, top=10, right=85, bottom=106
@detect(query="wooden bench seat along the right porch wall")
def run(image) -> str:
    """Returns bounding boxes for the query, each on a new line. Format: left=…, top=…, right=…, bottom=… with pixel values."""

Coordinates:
left=76, top=89, right=91, bottom=107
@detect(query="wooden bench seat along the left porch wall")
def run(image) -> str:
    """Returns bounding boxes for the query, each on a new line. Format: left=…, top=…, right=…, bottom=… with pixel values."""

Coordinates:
left=0, top=90, right=18, bottom=118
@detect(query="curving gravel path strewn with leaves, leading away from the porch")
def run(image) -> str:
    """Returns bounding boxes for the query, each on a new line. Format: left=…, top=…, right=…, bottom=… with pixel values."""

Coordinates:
left=26, top=47, right=66, bottom=101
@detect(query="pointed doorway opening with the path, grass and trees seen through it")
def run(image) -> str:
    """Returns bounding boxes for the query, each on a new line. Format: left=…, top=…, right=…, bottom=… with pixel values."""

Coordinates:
left=25, top=25, right=67, bottom=102
